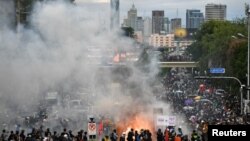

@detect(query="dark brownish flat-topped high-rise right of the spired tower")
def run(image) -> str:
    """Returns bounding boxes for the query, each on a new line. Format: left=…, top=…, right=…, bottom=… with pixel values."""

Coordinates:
left=152, top=10, right=164, bottom=34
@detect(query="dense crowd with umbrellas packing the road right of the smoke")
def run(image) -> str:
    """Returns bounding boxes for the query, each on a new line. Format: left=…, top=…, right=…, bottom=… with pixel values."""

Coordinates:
left=160, top=70, right=249, bottom=141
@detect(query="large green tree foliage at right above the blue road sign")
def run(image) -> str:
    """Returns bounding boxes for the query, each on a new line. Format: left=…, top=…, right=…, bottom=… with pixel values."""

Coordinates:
left=187, top=19, right=247, bottom=82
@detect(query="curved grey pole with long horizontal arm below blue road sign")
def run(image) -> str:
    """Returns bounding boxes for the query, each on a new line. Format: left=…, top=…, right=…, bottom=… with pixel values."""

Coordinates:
left=194, top=76, right=245, bottom=115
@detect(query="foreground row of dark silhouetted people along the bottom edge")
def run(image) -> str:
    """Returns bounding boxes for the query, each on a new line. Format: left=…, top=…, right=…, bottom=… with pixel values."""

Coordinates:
left=0, top=127, right=203, bottom=141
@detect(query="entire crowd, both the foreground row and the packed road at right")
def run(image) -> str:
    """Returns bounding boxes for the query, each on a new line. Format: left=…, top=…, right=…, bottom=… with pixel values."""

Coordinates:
left=0, top=67, right=249, bottom=141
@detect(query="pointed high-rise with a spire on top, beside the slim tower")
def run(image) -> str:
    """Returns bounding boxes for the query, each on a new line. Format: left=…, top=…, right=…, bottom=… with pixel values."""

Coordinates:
left=127, top=4, right=137, bottom=30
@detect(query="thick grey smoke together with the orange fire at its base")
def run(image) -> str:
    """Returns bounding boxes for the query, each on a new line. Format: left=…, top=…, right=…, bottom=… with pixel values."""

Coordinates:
left=0, top=1, right=186, bottom=137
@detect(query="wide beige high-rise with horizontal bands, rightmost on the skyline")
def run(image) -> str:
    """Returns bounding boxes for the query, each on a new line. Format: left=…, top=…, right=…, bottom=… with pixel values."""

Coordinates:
left=205, top=4, right=227, bottom=21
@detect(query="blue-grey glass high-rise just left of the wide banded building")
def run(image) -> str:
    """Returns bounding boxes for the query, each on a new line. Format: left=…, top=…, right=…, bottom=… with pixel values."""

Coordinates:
left=186, top=9, right=204, bottom=28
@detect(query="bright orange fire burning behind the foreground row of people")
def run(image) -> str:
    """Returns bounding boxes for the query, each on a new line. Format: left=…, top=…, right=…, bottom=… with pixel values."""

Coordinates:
left=117, top=114, right=154, bottom=135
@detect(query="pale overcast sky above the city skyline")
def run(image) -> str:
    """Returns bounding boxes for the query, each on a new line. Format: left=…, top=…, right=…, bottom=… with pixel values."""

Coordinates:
left=75, top=0, right=250, bottom=24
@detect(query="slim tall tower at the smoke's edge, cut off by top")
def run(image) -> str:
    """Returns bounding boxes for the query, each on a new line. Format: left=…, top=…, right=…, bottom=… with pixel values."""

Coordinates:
left=110, top=0, right=120, bottom=29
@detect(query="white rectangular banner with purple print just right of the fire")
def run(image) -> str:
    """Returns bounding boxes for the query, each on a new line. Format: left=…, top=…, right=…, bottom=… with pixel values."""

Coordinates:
left=156, top=115, right=176, bottom=126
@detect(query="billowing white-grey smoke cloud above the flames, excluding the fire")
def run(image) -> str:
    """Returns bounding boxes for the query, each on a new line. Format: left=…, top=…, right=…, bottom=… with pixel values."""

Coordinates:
left=0, top=1, right=189, bottom=135
